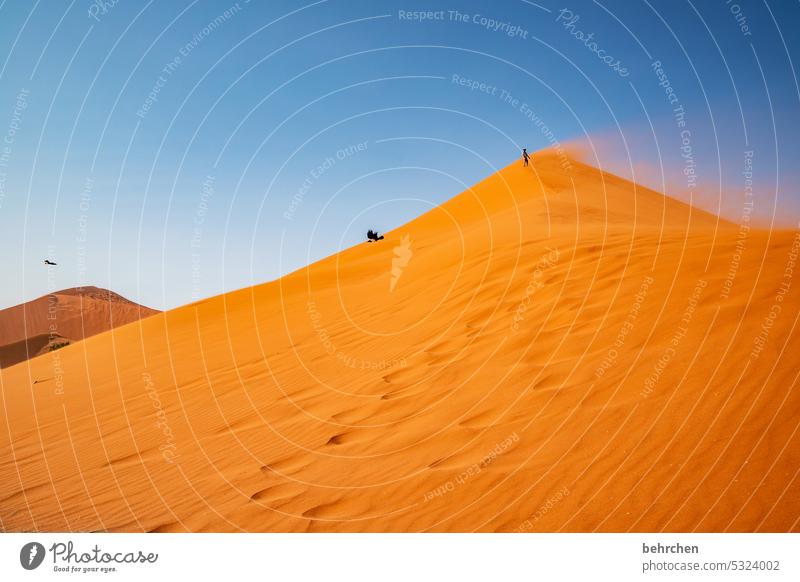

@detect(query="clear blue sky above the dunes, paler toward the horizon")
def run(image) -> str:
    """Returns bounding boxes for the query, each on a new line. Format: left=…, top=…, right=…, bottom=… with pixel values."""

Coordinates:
left=0, top=0, right=800, bottom=309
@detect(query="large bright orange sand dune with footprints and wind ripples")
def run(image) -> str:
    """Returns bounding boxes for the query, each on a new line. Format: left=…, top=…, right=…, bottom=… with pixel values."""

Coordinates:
left=0, top=153, right=800, bottom=531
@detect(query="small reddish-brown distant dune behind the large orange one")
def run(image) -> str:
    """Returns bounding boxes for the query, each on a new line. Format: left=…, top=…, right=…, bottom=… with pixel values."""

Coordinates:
left=0, top=287, right=158, bottom=368
